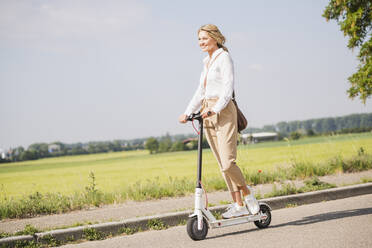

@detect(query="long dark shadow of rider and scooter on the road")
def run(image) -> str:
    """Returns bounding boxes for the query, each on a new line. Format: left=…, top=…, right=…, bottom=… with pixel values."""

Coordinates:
left=206, top=208, right=372, bottom=239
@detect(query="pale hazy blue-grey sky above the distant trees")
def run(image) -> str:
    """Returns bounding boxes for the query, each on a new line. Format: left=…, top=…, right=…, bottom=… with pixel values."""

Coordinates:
left=0, top=0, right=372, bottom=149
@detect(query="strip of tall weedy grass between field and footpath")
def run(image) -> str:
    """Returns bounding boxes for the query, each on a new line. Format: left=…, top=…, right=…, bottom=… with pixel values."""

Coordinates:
left=0, top=147, right=372, bottom=219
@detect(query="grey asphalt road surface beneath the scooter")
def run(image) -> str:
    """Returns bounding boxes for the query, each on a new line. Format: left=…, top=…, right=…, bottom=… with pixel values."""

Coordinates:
left=64, top=194, right=372, bottom=248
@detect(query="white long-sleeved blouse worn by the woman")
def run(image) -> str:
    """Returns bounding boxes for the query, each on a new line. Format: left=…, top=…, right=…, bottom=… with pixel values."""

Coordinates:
left=184, top=48, right=234, bottom=115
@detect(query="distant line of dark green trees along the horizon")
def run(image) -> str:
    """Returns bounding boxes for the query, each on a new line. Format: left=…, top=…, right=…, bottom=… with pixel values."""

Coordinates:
left=0, top=113, right=372, bottom=162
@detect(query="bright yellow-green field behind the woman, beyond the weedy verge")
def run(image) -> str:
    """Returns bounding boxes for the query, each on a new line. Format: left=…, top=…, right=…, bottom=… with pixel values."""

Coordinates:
left=0, top=133, right=372, bottom=197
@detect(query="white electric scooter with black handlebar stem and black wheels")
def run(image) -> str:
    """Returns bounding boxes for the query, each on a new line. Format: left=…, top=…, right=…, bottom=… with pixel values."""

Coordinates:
left=187, top=112, right=271, bottom=240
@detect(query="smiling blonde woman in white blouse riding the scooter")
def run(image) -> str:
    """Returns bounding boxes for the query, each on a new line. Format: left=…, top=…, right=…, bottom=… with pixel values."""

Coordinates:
left=179, top=24, right=259, bottom=218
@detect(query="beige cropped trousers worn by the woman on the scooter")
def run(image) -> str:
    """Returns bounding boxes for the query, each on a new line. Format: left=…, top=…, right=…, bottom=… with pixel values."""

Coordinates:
left=201, top=99, right=246, bottom=192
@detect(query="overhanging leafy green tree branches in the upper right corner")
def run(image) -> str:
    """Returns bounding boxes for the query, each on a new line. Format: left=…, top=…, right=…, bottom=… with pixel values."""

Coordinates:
left=323, top=0, right=372, bottom=104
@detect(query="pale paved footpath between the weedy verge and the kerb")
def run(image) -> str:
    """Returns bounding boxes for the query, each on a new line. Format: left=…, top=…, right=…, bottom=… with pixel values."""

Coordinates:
left=0, top=170, right=372, bottom=233
